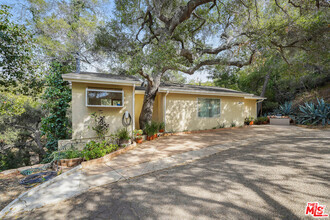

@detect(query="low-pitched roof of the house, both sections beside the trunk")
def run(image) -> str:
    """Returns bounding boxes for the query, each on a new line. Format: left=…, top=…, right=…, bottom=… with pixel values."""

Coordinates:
left=62, top=72, right=265, bottom=99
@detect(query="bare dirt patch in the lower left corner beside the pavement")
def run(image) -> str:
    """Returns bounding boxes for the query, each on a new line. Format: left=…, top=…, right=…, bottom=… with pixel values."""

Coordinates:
left=0, top=174, right=28, bottom=210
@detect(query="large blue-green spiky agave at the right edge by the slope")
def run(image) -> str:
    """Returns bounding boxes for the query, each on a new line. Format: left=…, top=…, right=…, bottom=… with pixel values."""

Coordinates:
left=298, top=99, right=330, bottom=126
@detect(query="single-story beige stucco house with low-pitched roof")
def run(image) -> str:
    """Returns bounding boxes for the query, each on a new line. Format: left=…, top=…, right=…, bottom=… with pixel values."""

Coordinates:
left=62, top=72, right=265, bottom=139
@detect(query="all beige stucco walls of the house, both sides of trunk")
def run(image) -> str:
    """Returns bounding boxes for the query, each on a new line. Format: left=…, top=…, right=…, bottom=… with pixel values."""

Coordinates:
left=72, top=82, right=256, bottom=139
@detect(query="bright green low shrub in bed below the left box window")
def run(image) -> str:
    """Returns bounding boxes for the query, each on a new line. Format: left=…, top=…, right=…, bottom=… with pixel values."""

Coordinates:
left=82, top=141, right=119, bottom=160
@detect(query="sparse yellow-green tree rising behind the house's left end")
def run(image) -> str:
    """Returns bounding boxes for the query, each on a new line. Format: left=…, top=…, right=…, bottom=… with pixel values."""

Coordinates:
left=28, top=0, right=100, bottom=73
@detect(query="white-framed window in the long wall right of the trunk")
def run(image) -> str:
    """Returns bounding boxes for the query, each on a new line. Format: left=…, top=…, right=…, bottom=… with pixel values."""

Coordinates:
left=197, top=98, right=220, bottom=118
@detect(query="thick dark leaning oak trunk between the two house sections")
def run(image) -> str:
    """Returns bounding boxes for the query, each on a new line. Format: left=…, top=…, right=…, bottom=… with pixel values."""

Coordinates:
left=139, top=77, right=160, bottom=129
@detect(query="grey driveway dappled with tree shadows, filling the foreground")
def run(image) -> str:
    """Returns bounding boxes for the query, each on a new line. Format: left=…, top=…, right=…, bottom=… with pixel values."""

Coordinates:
left=16, top=126, right=330, bottom=219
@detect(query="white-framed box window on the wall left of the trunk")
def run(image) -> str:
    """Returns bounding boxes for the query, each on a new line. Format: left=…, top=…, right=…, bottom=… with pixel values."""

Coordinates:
left=86, top=88, right=124, bottom=107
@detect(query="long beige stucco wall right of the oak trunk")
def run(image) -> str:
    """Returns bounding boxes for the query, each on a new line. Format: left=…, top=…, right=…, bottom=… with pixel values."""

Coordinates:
left=166, top=93, right=257, bottom=131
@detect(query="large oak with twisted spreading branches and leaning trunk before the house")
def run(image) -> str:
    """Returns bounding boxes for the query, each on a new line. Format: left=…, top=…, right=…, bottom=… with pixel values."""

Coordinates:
left=96, top=0, right=254, bottom=128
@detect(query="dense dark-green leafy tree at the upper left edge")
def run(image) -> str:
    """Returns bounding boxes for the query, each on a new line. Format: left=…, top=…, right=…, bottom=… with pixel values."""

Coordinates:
left=0, top=5, right=36, bottom=92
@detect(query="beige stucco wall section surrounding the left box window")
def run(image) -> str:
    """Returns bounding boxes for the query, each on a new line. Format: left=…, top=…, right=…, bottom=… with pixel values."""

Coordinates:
left=72, top=82, right=133, bottom=139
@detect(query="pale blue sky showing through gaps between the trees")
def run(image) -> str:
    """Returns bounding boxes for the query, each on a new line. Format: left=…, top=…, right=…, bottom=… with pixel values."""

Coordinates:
left=0, top=0, right=210, bottom=82
